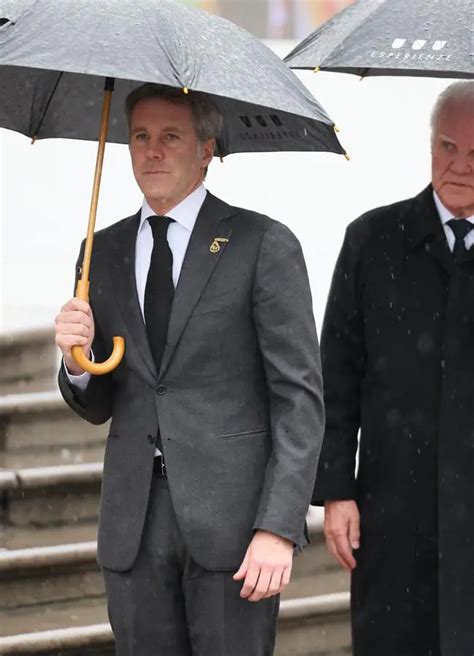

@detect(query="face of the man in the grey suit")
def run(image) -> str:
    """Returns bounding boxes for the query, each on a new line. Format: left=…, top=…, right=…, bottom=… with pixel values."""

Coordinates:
left=129, top=98, right=214, bottom=214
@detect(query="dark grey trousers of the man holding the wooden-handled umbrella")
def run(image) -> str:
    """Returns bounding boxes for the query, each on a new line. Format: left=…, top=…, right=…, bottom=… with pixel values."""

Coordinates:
left=104, top=474, right=279, bottom=656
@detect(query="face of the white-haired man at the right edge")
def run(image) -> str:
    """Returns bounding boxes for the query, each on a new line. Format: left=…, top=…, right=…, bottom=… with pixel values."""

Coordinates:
left=432, top=101, right=474, bottom=217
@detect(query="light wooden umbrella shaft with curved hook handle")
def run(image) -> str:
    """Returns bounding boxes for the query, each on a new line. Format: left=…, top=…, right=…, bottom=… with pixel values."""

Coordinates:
left=72, top=77, right=125, bottom=376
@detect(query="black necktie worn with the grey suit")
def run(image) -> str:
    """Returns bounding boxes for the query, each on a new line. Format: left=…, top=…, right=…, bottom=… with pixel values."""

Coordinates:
left=144, top=216, right=174, bottom=372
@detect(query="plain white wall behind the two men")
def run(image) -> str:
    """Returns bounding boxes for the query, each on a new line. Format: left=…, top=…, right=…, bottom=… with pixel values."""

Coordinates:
left=0, top=42, right=449, bottom=331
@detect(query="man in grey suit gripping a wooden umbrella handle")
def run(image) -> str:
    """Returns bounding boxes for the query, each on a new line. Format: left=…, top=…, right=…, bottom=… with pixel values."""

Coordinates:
left=56, top=84, right=324, bottom=656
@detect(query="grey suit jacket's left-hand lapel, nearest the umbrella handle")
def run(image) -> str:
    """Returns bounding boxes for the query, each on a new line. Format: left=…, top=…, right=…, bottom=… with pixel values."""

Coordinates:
left=109, top=212, right=157, bottom=385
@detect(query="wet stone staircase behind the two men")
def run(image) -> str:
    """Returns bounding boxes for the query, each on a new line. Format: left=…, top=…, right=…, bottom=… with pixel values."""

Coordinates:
left=0, top=330, right=351, bottom=656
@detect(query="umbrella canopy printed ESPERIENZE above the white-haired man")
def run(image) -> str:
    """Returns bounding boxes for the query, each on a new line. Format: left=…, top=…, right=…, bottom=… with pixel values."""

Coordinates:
left=285, top=0, right=474, bottom=79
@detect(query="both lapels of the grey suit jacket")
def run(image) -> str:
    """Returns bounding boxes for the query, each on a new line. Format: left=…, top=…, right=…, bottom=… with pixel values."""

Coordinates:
left=106, top=192, right=237, bottom=385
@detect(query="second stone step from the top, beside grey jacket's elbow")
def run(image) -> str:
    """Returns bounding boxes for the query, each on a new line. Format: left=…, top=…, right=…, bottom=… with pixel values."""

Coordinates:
left=0, top=391, right=108, bottom=469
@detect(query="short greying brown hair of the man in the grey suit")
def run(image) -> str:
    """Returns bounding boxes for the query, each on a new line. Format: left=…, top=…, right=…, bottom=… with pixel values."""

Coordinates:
left=125, top=82, right=223, bottom=143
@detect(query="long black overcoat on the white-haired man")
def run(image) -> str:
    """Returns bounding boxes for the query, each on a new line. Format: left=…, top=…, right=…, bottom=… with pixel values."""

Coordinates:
left=313, top=186, right=474, bottom=656
